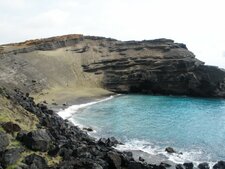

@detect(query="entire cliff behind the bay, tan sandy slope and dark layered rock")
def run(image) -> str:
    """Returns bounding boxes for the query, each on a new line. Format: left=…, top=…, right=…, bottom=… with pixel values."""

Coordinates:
left=0, top=35, right=225, bottom=97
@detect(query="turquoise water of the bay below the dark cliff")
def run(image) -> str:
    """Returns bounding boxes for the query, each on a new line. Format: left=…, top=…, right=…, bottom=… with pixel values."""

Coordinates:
left=72, top=95, right=225, bottom=162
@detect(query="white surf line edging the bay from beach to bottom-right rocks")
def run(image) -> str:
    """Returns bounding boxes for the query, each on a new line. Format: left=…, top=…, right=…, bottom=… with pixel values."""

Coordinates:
left=57, top=94, right=216, bottom=168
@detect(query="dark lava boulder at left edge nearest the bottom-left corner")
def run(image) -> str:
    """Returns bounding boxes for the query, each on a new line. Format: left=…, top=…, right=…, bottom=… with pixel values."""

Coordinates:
left=1, top=148, right=24, bottom=167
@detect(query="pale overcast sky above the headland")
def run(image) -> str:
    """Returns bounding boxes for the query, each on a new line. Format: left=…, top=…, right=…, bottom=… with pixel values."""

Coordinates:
left=0, top=0, right=225, bottom=68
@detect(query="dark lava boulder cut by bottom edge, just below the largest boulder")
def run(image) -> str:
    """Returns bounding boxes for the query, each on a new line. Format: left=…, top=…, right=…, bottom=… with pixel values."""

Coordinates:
left=23, top=154, right=48, bottom=169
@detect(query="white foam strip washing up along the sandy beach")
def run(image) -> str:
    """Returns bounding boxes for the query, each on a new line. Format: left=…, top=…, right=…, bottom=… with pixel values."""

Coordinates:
left=58, top=96, right=114, bottom=119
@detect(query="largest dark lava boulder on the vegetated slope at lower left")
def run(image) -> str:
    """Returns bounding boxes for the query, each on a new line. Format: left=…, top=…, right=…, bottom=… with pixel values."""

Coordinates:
left=21, top=129, right=51, bottom=152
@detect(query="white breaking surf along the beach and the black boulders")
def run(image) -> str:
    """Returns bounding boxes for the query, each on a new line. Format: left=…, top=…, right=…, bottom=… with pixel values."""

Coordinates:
left=58, top=95, right=215, bottom=168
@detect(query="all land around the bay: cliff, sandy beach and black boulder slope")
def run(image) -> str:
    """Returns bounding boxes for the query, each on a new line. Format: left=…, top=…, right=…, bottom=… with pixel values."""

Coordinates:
left=0, top=35, right=225, bottom=169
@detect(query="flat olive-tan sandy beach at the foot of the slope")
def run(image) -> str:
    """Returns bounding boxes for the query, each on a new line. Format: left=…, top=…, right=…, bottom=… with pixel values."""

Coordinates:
left=33, top=87, right=115, bottom=110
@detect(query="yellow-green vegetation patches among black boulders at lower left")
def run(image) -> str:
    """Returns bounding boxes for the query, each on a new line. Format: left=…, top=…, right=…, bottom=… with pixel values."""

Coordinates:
left=0, top=94, right=61, bottom=169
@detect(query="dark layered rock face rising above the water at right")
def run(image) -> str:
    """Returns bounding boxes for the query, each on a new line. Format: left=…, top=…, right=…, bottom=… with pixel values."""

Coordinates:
left=84, top=39, right=225, bottom=97
